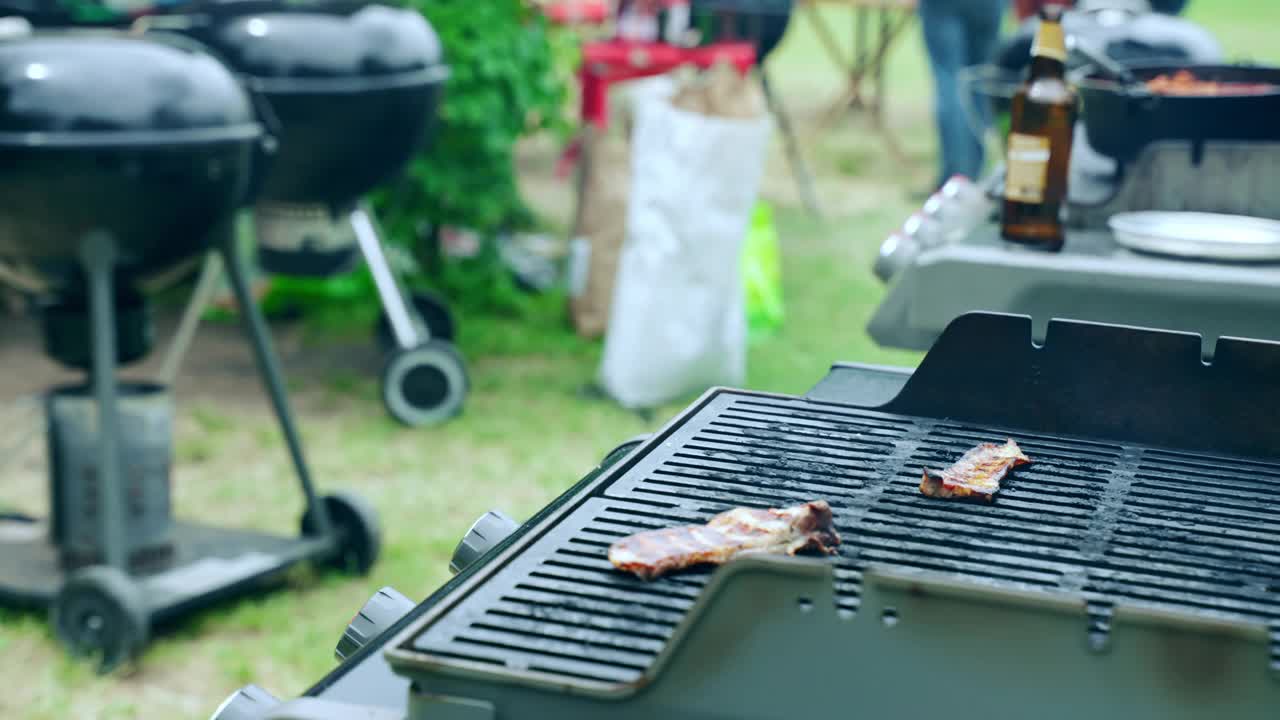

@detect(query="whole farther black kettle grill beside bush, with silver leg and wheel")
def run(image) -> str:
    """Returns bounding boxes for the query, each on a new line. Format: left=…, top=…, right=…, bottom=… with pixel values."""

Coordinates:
left=146, top=1, right=468, bottom=427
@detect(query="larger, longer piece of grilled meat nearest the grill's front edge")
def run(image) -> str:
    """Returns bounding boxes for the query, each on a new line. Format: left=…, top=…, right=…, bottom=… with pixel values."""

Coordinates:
left=609, top=500, right=840, bottom=580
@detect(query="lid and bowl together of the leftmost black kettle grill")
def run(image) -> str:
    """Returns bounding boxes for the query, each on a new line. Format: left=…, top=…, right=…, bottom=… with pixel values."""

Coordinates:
left=0, top=31, right=264, bottom=296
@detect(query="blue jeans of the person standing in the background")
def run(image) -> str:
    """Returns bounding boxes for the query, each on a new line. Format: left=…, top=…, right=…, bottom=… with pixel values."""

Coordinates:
left=919, top=0, right=1007, bottom=184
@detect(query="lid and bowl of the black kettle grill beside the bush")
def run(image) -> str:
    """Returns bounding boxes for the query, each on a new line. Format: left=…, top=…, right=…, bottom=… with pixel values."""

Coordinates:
left=165, top=3, right=448, bottom=208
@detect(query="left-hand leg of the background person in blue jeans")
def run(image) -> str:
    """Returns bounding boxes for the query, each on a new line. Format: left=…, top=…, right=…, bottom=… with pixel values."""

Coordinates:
left=918, top=0, right=982, bottom=184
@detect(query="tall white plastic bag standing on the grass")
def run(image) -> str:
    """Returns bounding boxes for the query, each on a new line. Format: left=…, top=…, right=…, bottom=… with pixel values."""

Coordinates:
left=600, top=83, right=771, bottom=407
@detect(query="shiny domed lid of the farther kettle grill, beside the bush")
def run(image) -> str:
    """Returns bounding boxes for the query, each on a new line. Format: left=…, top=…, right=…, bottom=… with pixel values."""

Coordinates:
left=207, top=5, right=443, bottom=91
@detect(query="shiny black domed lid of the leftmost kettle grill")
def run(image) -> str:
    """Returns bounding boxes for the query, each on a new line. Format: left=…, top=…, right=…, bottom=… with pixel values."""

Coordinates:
left=0, top=31, right=259, bottom=145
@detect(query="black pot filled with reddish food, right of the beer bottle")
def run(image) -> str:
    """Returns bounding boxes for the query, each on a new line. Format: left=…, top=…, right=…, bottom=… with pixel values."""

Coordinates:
left=1079, top=65, right=1280, bottom=160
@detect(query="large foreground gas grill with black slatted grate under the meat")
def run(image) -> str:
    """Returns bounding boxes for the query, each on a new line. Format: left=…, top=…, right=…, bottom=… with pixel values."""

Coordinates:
left=214, top=314, right=1280, bottom=720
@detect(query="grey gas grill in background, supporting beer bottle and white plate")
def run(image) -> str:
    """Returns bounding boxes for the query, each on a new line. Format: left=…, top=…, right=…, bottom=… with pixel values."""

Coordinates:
left=867, top=4, right=1280, bottom=350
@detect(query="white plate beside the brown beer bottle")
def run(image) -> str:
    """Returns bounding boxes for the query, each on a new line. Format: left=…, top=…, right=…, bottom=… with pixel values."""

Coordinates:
left=1107, top=211, right=1280, bottom=261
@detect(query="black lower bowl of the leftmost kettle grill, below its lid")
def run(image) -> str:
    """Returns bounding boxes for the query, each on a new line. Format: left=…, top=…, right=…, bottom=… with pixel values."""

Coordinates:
left=0, top=140, right=253, bottom=295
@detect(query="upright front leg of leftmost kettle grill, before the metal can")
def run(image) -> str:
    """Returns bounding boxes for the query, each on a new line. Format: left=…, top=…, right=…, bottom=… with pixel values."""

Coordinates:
left=81, top=233, right=128, bottom=571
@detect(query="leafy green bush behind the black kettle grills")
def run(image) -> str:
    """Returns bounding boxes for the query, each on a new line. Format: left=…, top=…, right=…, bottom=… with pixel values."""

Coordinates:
left=268, top=0, right=577, bottom=319
